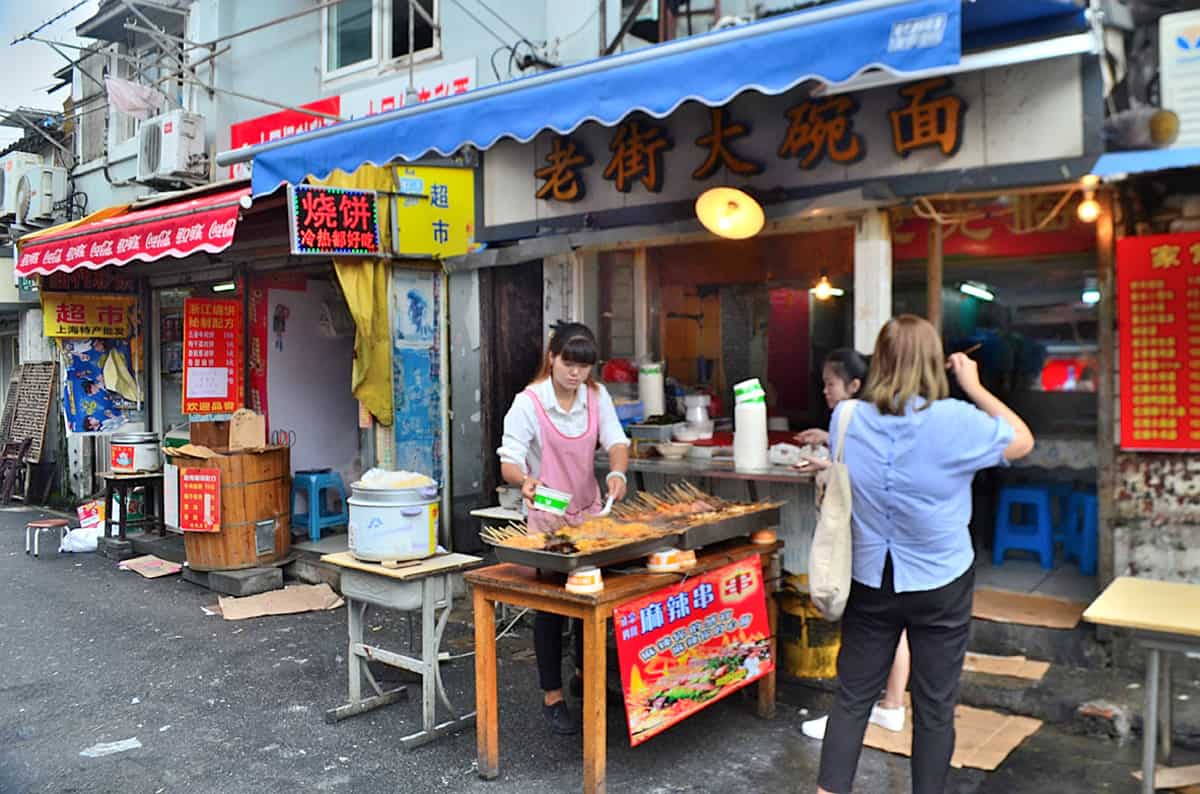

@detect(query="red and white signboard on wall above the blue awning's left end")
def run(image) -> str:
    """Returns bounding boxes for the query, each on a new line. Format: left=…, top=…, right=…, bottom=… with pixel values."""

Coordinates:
left=229, top=59, right=478, bottom=179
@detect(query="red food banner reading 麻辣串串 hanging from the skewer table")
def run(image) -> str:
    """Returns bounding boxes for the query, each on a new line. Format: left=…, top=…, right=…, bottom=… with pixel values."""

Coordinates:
left=612, top=554, right=775, bottom=746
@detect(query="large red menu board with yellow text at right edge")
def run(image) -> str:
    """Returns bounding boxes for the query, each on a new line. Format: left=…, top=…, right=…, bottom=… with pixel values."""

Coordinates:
left=1117, top=234, right=1200, bottom=451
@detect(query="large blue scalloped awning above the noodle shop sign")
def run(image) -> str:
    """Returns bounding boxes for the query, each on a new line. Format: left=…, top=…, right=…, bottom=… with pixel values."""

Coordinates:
left=217, top=0, right=1094, bottom=196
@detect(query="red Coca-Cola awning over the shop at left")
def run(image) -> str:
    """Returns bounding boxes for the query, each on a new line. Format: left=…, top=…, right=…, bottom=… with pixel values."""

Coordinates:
left=17, top=187, right=250, bottom=276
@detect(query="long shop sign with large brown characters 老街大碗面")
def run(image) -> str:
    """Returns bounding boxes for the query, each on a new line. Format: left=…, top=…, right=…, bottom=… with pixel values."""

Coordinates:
left=484, top=58, right=1085, bottom=229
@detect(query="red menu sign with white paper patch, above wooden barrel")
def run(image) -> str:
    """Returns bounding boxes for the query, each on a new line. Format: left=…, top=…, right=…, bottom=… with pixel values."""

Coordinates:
left=184, top=297, right=244, bottom=415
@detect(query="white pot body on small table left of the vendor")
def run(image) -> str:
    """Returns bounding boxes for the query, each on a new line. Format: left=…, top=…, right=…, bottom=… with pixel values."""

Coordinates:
left=346, top=482, right=440, bottom=563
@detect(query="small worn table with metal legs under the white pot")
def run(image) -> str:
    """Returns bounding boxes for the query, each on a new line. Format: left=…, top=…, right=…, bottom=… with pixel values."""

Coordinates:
left=320, top=552, right=482, bottom=748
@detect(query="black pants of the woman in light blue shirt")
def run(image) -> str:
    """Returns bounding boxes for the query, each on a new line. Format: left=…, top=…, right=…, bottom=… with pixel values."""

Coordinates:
left=817, top=555, right=974, bottom=794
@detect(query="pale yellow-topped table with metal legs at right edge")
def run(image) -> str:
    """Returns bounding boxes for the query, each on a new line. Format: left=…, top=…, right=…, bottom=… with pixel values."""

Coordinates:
left=1084, top=576, right=1200, bottom=794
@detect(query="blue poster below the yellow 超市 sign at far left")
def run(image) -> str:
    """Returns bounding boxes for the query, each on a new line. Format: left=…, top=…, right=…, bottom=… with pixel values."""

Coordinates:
left=59, top=338, right=145, bottom=434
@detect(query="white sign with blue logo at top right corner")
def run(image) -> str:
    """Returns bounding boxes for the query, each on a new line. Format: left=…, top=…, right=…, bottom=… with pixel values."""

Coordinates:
left=1158, top=11, right=1200, bottom=148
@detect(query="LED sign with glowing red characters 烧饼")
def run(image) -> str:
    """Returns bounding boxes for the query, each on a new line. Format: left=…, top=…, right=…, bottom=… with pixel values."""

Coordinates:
left=288, top=185, right=379, bottom=257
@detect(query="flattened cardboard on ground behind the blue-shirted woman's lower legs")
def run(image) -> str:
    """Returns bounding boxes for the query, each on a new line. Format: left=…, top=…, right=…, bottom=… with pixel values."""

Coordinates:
left=863, top=703, right=1042, bottom=772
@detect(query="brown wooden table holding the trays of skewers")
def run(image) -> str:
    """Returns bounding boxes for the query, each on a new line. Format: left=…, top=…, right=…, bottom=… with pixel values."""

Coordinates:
left=464, top=540, right=782, bottom=794
